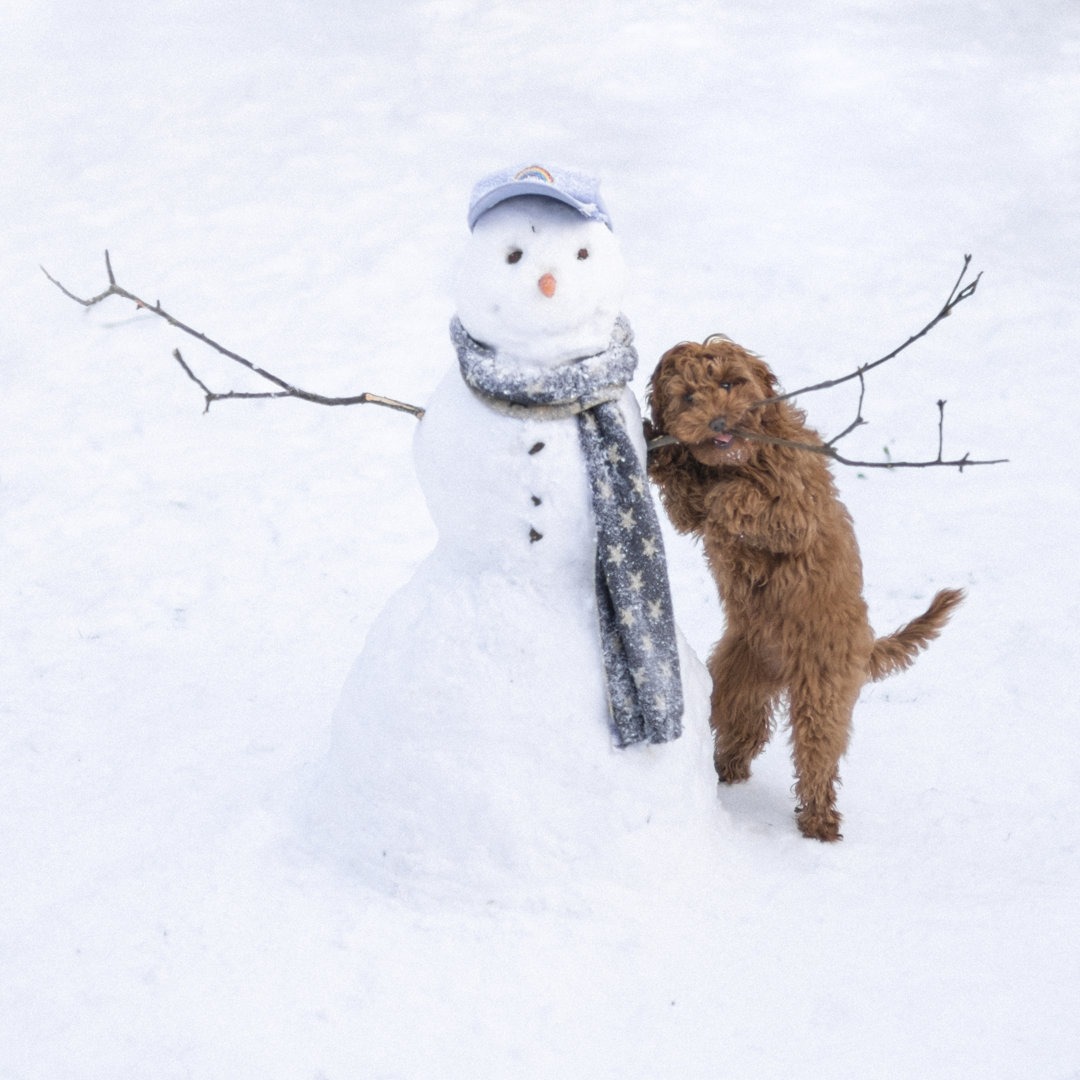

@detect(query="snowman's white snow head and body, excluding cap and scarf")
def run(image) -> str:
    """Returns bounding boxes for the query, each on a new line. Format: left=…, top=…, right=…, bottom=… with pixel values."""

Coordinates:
left=315, top=199, right=715, bottom=894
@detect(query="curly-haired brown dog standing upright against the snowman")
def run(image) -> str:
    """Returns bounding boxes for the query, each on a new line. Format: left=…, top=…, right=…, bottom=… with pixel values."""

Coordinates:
left=649, top=335, right=963, bottom=840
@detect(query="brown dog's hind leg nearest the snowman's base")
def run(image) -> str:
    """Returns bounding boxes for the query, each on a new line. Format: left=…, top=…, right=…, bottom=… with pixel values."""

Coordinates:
left=708, top=634, right=781, bottom=784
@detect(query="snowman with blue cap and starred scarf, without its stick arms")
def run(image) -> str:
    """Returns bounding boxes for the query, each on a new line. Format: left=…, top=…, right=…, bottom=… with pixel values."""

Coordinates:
left=320, top=165, right=717, bottom=888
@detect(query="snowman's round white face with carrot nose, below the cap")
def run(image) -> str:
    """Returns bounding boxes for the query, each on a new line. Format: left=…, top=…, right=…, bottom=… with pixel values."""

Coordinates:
left=457, top=195, right=626, bottom=366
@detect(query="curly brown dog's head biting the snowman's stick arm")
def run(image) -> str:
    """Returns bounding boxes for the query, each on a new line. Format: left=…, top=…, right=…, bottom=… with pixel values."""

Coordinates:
left=649, top=335, right=778, bottom=467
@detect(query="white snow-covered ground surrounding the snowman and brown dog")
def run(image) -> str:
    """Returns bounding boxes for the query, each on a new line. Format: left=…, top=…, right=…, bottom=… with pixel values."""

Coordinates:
left=0, top=0, right=1080, bottom=1080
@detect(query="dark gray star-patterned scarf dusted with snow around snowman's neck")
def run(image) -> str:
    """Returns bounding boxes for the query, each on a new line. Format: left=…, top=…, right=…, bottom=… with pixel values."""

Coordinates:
left=450, top=315, right=683, bottom=746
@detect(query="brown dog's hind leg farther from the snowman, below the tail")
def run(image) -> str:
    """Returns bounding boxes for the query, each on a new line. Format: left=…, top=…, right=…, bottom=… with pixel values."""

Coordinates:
left=791, top=678, right=859, bottom=840
